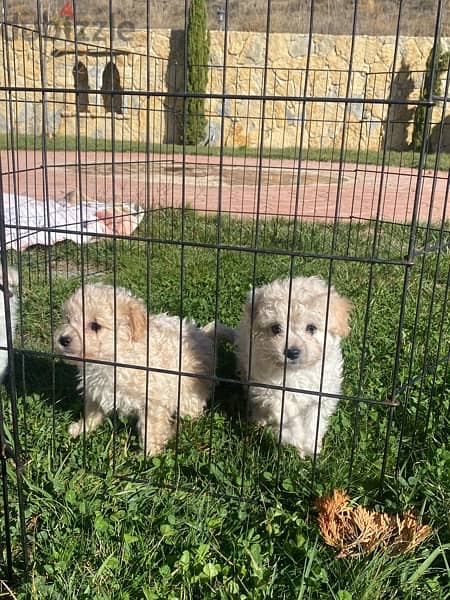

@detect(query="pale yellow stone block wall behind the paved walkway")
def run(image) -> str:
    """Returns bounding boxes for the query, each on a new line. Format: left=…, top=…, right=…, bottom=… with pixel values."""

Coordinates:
left=0, top=27, right=448, bottom=151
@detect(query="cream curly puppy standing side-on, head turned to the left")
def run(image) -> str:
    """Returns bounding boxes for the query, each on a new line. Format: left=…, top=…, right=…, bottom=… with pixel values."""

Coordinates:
left=55, top=284, right=215, bottom=456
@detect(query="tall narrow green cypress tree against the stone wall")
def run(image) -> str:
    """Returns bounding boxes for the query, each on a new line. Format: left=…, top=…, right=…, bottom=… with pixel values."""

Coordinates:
left=183, top=0, right=209, bottom=144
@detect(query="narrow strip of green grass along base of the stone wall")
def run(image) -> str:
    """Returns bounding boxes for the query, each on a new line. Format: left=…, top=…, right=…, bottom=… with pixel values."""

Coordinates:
left=0, top=133, right=450, bottom=171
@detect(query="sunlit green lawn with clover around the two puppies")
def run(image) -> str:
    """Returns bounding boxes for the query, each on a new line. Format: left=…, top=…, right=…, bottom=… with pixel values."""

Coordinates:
left=0, top=210, right=450, bottom=600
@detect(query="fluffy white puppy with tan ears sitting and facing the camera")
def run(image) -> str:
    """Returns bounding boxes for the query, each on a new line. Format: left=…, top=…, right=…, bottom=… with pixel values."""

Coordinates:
left=236, top=277, right=351, bottom=456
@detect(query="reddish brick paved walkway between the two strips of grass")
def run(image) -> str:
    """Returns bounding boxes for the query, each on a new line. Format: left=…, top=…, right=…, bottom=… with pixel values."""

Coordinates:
left=1, top=151, right=448, bottom=223
